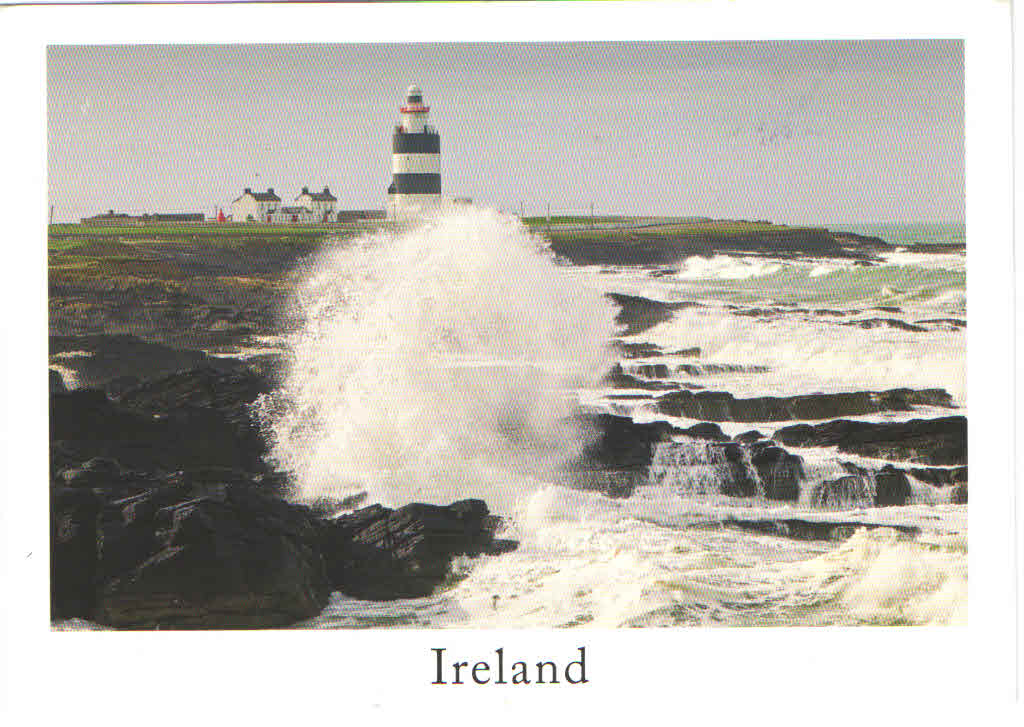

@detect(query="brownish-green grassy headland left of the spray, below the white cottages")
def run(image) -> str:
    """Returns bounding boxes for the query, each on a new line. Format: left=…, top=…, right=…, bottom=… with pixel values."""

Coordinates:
left=48, top=221, right=377, bottom=348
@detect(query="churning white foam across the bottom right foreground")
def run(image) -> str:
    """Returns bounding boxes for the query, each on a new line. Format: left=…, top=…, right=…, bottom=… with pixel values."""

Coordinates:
left=301, top=485, right=967, bottom=628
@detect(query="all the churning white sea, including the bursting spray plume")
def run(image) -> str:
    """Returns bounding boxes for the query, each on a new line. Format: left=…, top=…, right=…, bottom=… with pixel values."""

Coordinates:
left=249, top=210, right=968, bottom=628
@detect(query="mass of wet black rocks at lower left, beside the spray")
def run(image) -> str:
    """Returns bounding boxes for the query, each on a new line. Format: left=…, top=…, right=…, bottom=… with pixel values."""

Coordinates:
left=50, top=369, right=516, bottom=629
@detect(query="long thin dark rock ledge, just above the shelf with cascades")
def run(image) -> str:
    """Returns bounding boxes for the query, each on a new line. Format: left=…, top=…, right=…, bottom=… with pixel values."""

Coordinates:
left=657, top=389, right=951, bottom=422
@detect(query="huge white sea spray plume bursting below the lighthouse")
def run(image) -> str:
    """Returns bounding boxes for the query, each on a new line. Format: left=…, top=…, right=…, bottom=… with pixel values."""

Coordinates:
left=257, top=209, right=615, bottom=512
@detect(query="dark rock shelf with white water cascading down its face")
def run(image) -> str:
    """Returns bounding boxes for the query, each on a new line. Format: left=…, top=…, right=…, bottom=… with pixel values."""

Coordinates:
left=570, top=415, right=968, bottom=510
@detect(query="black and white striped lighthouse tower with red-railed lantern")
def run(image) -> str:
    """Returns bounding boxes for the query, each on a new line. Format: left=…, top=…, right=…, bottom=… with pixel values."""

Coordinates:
left=387, top=85, right=441, bottom=219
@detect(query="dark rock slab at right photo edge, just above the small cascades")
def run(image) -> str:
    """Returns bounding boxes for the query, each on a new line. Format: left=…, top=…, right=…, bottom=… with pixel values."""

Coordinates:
left=772, top=417, right=967, bottom=465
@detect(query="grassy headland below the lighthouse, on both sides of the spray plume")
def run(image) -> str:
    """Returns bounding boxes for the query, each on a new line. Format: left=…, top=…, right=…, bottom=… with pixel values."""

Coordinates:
left=48, top=216, right=887, bottom=348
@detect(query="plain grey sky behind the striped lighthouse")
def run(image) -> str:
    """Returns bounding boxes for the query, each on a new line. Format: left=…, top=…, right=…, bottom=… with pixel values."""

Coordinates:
left=47, top=40, right=964, bottom=222
